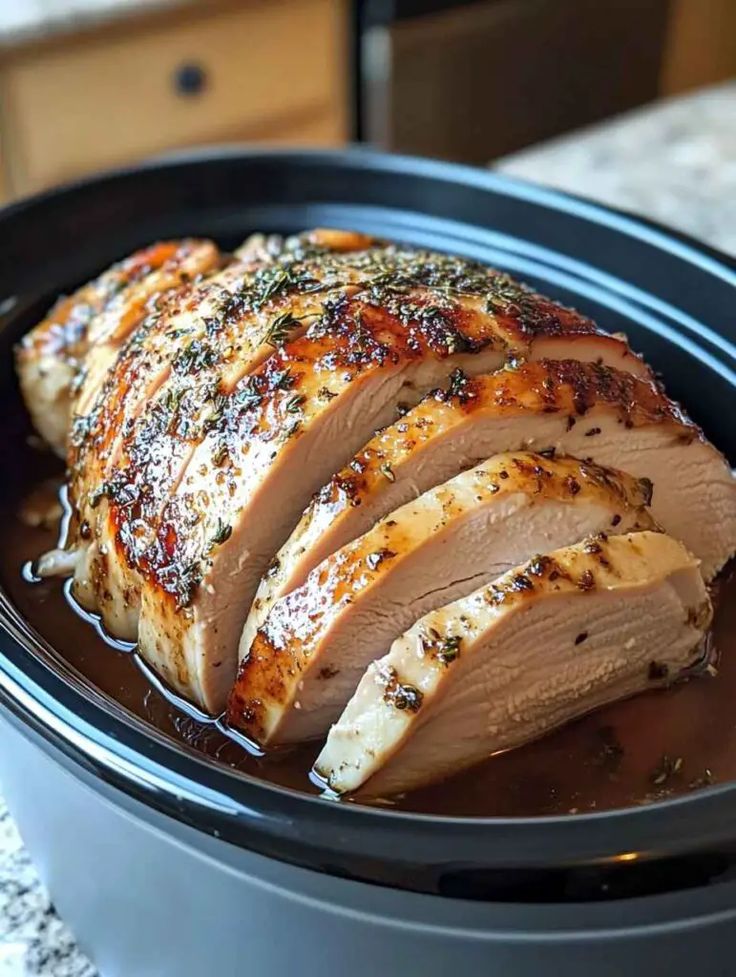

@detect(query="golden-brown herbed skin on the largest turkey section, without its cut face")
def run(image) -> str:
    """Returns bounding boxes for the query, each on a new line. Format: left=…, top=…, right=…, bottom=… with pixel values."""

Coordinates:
left=18, top=229, right=646, bottom=712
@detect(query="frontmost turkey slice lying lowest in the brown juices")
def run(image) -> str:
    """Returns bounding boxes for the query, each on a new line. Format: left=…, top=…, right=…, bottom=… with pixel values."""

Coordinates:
left=315, top=532, right=712, bottom=797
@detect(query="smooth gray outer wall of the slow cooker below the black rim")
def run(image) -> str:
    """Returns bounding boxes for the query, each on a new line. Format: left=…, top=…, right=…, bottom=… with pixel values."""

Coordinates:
left=0, top=721, right=736, bottom=977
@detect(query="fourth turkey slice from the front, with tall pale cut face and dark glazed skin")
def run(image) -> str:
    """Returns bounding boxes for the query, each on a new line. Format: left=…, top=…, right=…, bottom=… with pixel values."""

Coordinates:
left=134, top=286, right=634, bottom=711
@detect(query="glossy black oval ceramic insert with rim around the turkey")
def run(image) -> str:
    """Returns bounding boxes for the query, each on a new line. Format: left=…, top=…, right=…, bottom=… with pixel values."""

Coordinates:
left=0, top=149, right=736, bottom=901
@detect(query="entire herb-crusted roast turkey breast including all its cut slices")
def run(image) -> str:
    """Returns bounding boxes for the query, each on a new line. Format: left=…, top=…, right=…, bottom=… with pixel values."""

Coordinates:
left=17, top=228, right=736, bottom=793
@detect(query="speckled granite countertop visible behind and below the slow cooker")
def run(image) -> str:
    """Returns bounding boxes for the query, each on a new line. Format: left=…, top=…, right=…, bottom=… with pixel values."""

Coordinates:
left=0, top=80, right=736, bottom=977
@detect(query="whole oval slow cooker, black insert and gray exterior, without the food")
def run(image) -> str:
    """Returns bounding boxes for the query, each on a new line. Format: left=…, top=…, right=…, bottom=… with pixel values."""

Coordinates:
left=0, top=148, right=736, bottom=977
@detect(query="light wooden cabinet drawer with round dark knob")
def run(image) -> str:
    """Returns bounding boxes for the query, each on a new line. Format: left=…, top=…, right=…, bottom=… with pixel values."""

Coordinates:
left=0, top=0, right=348, bottom=194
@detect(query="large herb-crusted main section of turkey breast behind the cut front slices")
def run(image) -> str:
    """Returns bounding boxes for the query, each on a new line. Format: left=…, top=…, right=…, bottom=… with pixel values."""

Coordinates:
left=46, top=232, right=647, bottom=709
